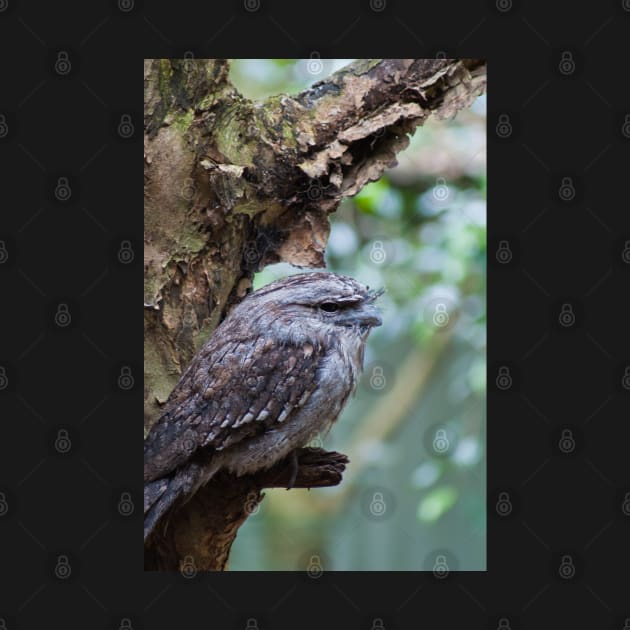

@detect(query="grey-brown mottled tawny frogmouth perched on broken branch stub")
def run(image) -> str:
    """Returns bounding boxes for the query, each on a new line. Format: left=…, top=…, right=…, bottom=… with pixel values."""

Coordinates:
left=144, top=271, right=383, bottom=542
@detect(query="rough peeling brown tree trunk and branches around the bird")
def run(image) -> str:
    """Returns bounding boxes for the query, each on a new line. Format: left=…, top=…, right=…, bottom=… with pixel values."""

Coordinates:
left=144, top=59, right=486, bottom=570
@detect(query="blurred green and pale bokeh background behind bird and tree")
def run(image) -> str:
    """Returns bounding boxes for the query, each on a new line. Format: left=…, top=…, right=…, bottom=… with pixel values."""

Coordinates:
left=230, top=59, right=486, bottom=571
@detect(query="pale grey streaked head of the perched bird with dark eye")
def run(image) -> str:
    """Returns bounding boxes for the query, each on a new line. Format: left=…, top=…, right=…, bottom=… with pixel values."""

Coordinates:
left=230, top=272, right=383, bottom=344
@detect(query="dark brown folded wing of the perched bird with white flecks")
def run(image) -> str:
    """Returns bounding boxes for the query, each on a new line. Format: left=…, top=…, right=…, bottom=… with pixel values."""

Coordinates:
left=144, top=337, right=323, bottom=481
